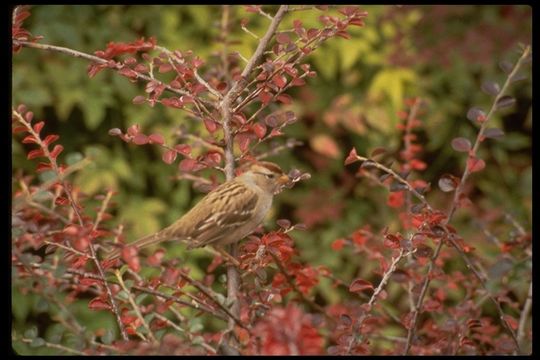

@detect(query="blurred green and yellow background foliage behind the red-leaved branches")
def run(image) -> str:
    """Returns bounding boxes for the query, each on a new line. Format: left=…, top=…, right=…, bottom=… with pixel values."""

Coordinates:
left=12, top=5, right=532, bottom=354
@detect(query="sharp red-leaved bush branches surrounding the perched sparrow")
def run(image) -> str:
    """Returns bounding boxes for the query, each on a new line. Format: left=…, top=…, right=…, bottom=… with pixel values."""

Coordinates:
left=11, top=5, right=532, bottom=355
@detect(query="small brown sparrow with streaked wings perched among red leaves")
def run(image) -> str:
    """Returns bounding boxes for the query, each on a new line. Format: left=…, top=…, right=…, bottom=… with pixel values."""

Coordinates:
left=105, top=161, right=291, bottom=260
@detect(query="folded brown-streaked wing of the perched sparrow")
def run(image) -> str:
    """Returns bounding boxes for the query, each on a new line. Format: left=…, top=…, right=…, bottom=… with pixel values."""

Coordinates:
left=184, top=181, right=258, bottom=248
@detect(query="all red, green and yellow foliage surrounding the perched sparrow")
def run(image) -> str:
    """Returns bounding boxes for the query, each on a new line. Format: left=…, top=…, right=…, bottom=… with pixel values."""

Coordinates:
left=12, top=5, right=532, bottom=355
